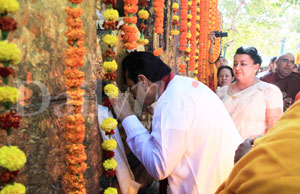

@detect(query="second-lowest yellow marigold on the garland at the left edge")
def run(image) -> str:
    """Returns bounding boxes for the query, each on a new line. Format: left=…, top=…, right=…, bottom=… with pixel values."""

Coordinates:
left=0, top=146, right=26, bottom=172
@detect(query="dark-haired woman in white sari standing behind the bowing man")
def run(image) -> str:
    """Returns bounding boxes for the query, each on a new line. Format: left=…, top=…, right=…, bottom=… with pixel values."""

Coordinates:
left=217, top=47, right=283, bottom=139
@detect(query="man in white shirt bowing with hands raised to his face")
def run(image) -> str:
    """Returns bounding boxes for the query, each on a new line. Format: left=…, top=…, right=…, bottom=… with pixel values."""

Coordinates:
left=112, top=52, right=242, bottom=194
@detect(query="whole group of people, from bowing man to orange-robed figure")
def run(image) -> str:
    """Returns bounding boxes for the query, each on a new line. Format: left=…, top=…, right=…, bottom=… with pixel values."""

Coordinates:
left=106, top=31, right=300, bottom=194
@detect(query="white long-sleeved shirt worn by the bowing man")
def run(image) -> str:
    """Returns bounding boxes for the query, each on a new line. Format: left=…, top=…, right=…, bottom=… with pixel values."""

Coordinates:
left=122, top=76, right=242, bottom=194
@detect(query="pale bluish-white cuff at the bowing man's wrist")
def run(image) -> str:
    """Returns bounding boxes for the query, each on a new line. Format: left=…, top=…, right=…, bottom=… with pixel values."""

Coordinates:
left=122, top=115, right=149, bottom=139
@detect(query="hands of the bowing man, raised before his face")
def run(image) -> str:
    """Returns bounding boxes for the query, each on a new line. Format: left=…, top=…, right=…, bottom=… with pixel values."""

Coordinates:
left=109, top=93, right=134, bottom=122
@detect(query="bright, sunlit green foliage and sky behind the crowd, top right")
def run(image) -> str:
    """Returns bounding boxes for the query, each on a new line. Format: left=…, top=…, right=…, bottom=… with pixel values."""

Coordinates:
left=219, top=0, right=300, bottom=65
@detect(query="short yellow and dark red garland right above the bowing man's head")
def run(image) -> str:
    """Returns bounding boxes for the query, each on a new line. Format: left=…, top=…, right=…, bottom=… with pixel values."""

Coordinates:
left=137, top=0, right=149, bottom=45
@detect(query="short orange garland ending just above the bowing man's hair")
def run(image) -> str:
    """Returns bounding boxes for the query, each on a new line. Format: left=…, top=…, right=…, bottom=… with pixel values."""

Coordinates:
left=121, top=0, right=138, bottom=52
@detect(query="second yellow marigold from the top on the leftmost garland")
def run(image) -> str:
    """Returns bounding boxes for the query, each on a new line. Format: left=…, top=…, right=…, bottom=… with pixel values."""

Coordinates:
left=0, top=40, right=22, bottom=65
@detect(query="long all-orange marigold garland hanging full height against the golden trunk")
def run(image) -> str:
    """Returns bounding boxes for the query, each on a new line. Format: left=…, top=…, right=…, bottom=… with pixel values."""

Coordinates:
left=63, top=0, right=87, bottom=194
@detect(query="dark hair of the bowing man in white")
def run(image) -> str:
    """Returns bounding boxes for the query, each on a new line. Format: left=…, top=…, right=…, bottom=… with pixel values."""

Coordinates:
left=122, top=52, right=171, bottom=83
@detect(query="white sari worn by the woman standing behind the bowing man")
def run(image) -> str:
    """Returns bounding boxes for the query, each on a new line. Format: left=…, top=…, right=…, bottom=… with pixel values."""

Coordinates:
left=216, top=81, right=283, bottom=139
